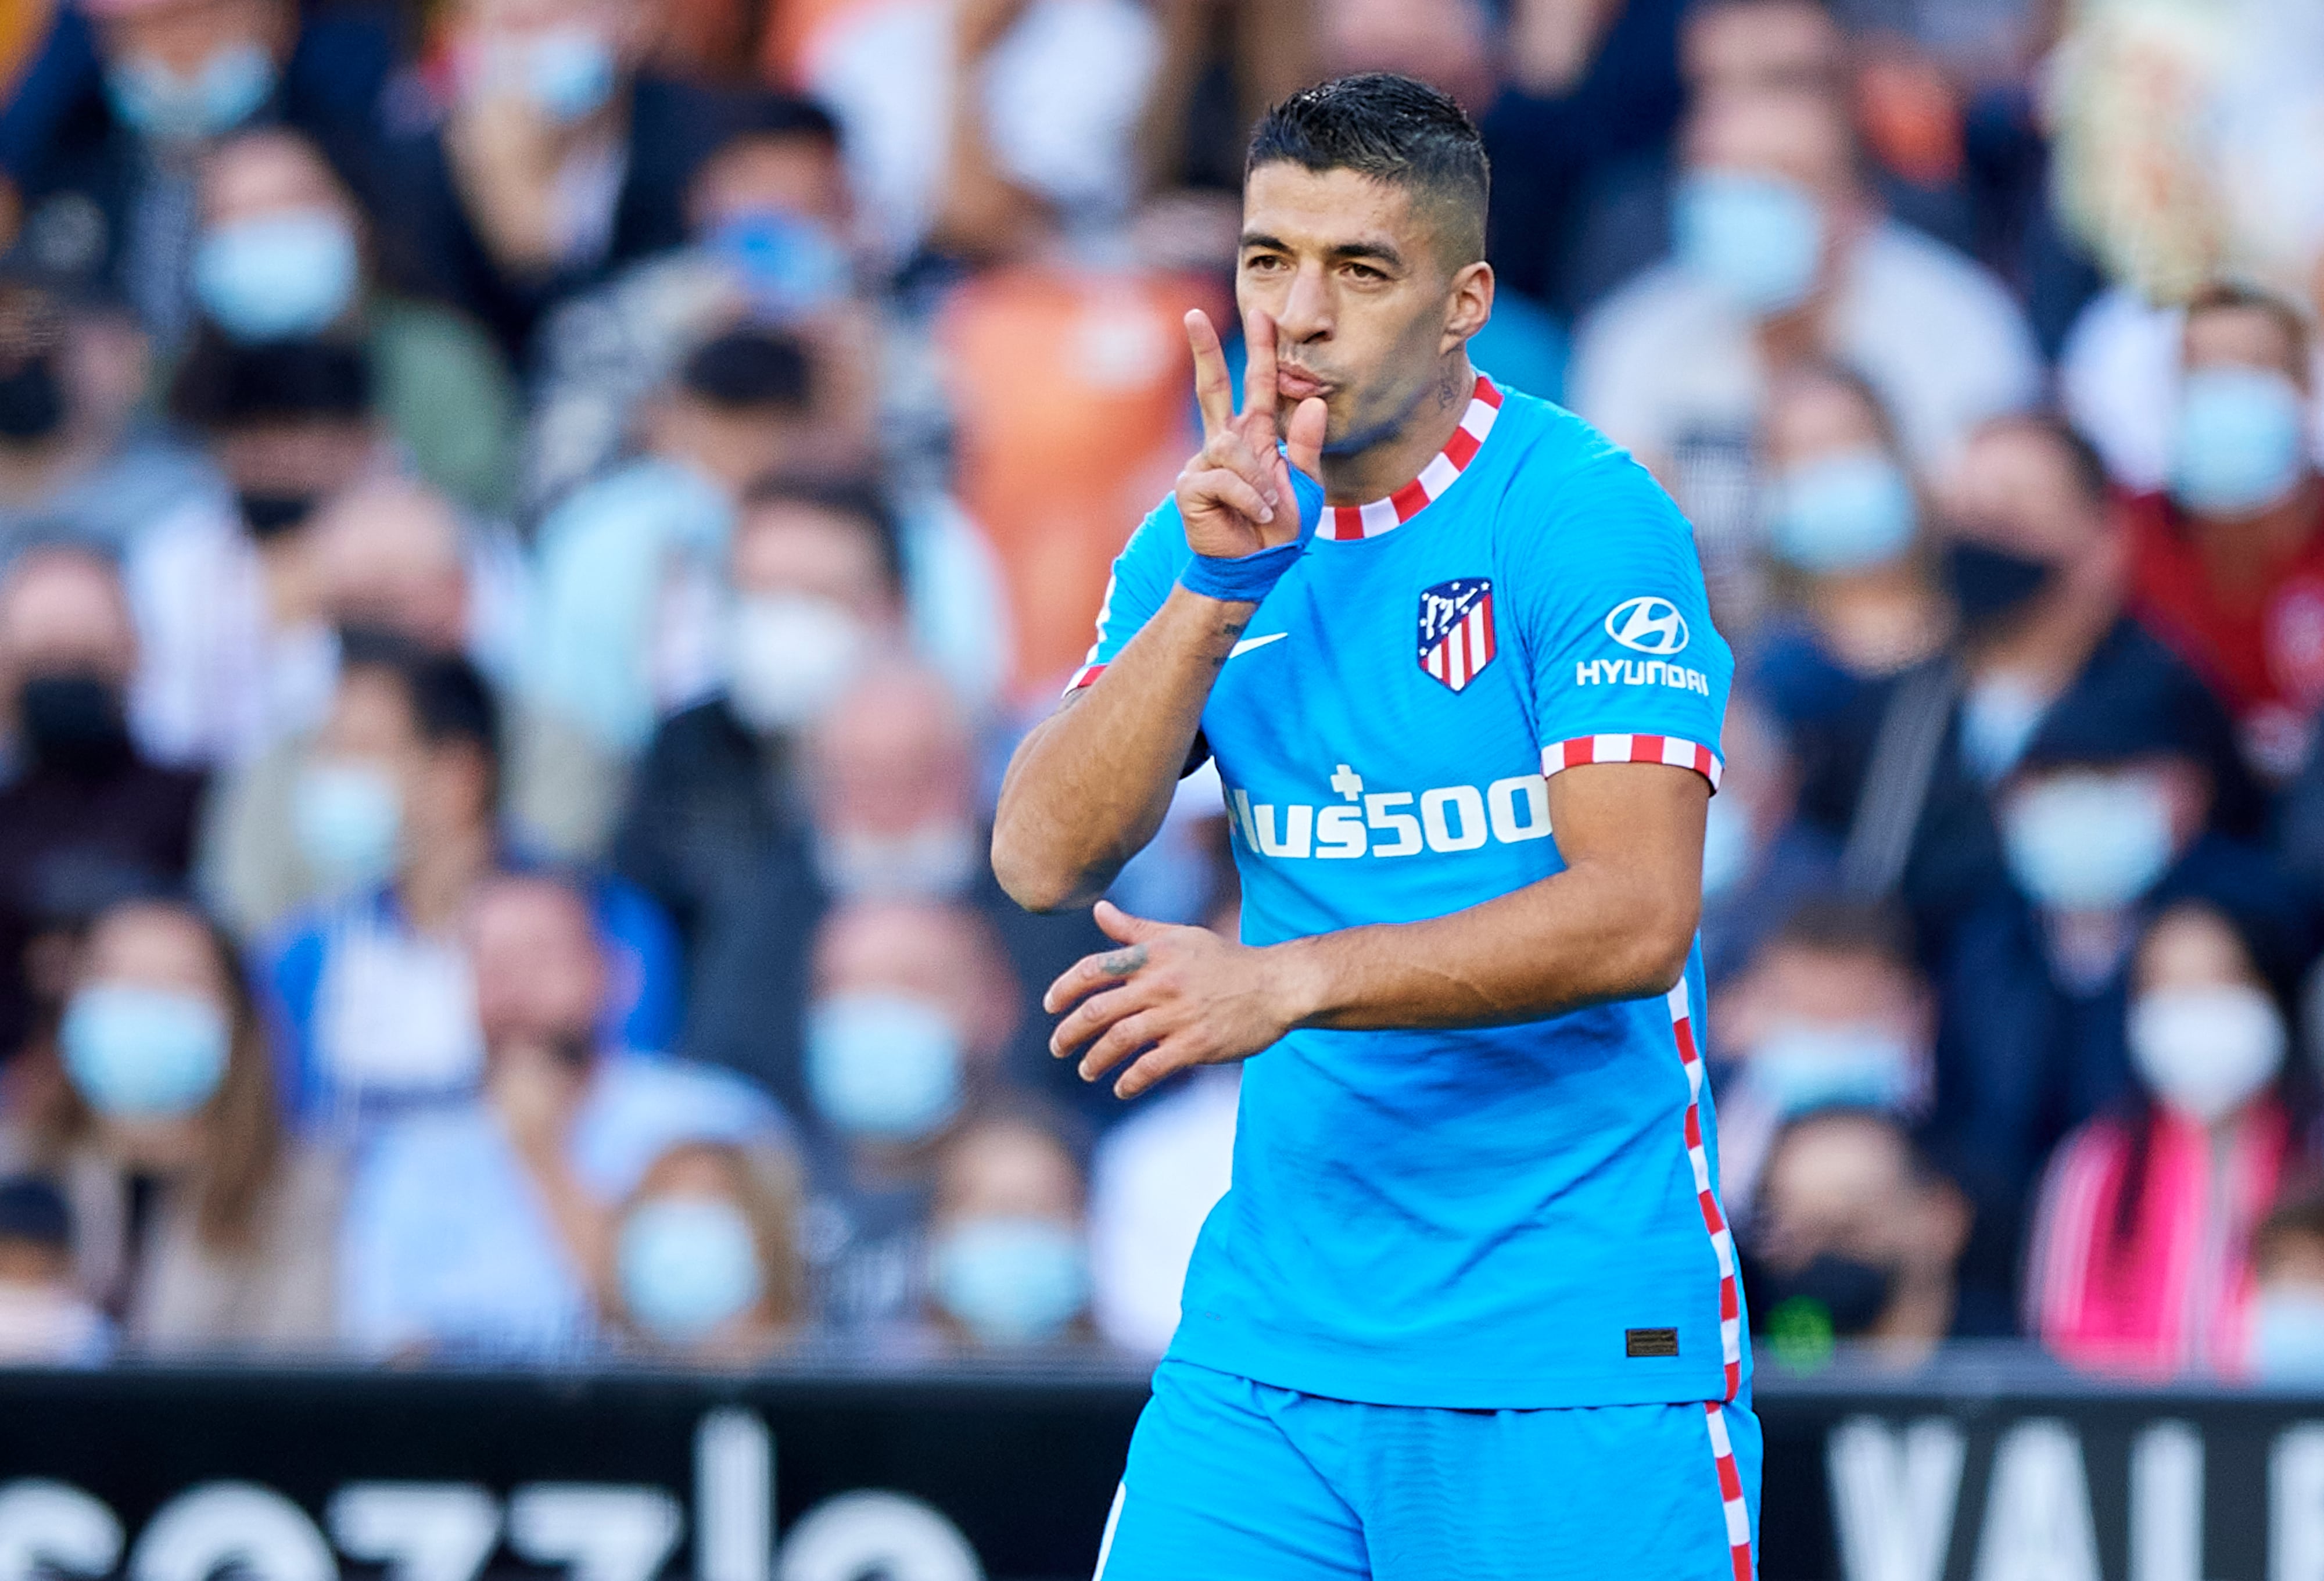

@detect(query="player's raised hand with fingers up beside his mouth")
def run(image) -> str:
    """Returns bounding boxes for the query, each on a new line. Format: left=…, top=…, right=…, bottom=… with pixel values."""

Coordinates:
left=1178, top=307, right=1325, bottom=558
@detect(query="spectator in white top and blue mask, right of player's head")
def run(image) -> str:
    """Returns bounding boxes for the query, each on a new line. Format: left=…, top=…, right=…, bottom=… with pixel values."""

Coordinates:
left=1571, top=80, right=2040, bottom=546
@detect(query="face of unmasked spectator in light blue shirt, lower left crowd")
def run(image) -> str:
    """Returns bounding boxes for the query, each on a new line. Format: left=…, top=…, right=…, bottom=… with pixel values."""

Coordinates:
left=467, top=879, right=607, bottom=1053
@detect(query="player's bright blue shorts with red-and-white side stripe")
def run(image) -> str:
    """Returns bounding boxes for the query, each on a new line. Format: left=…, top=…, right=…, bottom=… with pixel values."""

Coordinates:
left=1097, top=1363, right=1759, bottom=1581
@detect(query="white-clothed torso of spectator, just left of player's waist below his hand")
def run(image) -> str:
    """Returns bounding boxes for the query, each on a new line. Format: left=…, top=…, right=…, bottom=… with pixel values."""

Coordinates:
left=1090, top=1065, right=1243, bottom=1356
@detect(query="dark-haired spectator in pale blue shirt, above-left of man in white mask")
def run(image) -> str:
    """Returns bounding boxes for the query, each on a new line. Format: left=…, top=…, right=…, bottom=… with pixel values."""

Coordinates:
left=518, top=330, right=813, bottom=851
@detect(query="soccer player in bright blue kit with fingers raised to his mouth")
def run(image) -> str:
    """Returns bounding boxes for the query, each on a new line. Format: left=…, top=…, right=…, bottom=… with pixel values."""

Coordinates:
left=992, top=74, right=1759, bottom=1581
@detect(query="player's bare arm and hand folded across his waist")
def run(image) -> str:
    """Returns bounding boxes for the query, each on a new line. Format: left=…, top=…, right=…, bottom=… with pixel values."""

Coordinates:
left=1043, top=762, right=1710, bottom=1098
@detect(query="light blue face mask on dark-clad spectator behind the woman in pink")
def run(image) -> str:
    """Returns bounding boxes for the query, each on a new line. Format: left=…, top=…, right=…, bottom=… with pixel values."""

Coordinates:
left=2001, top=772, right=2173, bottom=912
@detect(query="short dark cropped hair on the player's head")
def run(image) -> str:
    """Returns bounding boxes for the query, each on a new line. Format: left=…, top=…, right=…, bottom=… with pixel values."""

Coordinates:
left=1243, top=72, right=1492, bottom=265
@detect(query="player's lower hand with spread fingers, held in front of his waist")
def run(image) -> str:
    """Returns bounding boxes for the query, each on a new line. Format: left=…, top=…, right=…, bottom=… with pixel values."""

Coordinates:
left=1041, top=900, right=1292, bottom=1098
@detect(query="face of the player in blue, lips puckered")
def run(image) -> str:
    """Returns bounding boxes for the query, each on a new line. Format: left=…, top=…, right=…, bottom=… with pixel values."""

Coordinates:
left=1234, top=160, right=1490, bottom=451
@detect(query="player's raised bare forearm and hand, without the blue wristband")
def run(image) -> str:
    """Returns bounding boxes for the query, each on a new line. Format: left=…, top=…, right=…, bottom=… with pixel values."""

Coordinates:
left=992, top=309, right=1325, bottom=912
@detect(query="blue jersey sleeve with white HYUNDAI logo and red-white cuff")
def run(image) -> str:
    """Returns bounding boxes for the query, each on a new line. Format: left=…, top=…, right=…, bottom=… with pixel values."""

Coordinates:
left=1511, top=444, right=1734, bottom=791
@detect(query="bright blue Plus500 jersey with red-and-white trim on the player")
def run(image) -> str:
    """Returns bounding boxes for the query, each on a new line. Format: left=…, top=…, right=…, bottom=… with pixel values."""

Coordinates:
left=1076, top=379, right=1748, bottom=1409
